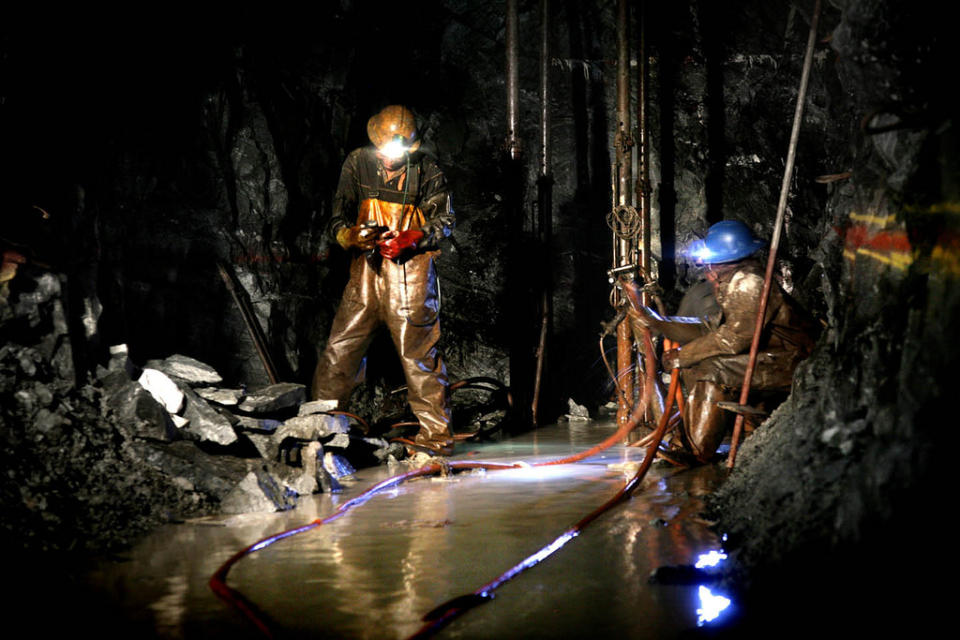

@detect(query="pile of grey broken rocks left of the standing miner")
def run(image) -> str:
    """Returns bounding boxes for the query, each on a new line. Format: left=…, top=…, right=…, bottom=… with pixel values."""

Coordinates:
left=0, top=268, right=404, bottom=551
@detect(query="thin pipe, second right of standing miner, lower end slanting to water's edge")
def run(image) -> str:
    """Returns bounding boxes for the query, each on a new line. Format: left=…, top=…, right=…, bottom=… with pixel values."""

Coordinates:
left=531, top=0, right=553, bottom=426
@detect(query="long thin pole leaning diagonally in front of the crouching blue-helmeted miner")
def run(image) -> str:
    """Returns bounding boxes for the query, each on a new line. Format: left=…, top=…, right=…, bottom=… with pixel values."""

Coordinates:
left=727, top=0, right=820, bottom=469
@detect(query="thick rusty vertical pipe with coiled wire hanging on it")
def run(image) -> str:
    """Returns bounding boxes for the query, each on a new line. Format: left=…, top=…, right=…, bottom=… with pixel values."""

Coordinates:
left=613, top=0, right=634, bottom=425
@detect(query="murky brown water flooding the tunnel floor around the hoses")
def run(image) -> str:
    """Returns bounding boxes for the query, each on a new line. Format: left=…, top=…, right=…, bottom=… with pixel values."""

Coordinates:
left=89, top=422, right=720, bottom=638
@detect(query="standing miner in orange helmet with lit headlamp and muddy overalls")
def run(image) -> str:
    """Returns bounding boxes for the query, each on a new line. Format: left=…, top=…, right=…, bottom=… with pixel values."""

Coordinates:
left=312, top=105, right=454, bottom=455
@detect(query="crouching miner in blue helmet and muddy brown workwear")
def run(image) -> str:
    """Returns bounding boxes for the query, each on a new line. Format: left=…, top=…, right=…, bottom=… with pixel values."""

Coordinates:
left=630, top=220, right=817, bottom=462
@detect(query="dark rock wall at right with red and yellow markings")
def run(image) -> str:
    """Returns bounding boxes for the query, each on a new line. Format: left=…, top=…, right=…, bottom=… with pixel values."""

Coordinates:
left=700, top=0, right=960, bottom=633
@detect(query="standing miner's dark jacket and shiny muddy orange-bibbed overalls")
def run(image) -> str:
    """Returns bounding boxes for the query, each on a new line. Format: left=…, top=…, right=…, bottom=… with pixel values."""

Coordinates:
left=313, top=147, right=454, bottom=442
